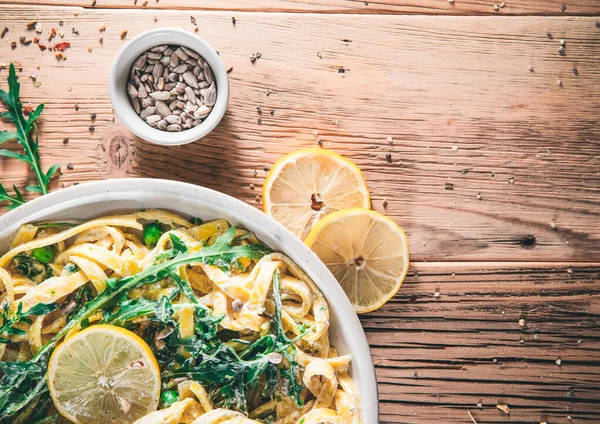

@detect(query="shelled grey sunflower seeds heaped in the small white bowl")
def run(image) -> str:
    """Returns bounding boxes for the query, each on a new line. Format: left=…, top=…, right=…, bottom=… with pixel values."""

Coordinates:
left=127, top=45, right=217, bottom=132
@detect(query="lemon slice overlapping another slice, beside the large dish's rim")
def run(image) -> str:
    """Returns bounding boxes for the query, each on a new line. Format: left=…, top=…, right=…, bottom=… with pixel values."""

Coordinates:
left=306, top=209, right=409, bottom=313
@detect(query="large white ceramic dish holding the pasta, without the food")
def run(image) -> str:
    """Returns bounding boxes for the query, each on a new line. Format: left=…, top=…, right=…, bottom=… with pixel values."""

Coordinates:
left=0, top=178, right=379, bottom=424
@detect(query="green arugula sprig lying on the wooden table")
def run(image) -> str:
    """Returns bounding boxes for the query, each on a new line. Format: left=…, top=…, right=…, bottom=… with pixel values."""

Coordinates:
left=0, top=63, right=60, bottom=208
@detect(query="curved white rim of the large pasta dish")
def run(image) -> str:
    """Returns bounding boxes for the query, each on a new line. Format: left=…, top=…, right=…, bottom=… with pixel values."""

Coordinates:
left=0, top=178, right=379, bottom=424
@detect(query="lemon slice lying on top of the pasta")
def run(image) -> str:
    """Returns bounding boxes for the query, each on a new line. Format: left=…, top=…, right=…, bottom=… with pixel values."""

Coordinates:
left=47, top=325, right=160, bottom=424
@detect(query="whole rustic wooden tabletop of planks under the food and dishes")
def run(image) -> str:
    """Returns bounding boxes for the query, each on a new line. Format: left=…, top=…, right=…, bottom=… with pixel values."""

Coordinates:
left=0, top=0, right=600, bottom=424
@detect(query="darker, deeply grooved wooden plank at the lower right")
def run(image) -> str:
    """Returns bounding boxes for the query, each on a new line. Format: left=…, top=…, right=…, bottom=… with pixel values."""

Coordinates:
left=361, top=263, right=600, bottom=423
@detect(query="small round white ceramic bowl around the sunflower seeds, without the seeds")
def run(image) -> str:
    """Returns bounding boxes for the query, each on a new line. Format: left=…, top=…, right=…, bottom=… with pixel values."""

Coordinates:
left=108, top=28, right=229, bottom=146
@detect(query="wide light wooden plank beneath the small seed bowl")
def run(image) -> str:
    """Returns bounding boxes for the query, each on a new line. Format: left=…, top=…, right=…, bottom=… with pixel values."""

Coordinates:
left=0, top=6, right=600, bottom=261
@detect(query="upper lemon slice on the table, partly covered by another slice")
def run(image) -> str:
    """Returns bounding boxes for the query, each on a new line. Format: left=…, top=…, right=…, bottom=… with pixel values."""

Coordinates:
left=263, top=149, right=370, bottom=239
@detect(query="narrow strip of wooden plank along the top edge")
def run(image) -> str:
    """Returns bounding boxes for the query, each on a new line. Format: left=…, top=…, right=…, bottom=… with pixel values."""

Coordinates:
left=0, top=0, right=600, bottom=16
